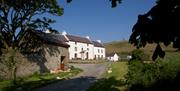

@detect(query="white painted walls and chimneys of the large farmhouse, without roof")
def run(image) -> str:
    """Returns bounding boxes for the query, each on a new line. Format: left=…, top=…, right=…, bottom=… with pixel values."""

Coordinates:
left=62, top=31, right=106, bottom=60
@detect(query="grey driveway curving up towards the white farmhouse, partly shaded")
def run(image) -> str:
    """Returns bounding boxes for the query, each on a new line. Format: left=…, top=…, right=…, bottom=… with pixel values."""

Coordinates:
left=34, top=62, right=108, bottom=91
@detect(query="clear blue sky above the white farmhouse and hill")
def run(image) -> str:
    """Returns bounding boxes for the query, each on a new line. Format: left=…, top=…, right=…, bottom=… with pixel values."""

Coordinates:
left=51, top=0, right=155, bottom=43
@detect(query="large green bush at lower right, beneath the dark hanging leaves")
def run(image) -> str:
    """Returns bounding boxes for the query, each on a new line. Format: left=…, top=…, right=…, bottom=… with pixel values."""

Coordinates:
left=126, top=54, right=180, bottom=91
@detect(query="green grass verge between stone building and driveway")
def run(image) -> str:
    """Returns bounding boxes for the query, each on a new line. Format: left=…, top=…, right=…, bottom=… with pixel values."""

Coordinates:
left=0, top=68, right=82, bottom=91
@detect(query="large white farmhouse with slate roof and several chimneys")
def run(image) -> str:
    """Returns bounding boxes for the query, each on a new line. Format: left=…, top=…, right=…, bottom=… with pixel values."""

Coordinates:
left=62, top=32, right=105, bottom=60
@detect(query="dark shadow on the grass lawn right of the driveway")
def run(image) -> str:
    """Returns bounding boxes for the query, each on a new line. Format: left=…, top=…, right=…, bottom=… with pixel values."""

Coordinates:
left=87, top=77, right=125, bottom=91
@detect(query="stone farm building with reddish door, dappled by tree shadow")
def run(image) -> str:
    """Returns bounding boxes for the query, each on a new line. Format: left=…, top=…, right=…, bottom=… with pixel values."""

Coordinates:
left=0, top=31, right=69, bottom=79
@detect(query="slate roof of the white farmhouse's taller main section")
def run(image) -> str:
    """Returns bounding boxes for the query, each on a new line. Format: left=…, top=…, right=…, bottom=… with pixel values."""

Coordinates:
left=66, top=35, right=93, bottom=44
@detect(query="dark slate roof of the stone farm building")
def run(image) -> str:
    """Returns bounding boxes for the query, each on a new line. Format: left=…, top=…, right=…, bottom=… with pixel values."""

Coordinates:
left=32, top=31, right=70, bottom=48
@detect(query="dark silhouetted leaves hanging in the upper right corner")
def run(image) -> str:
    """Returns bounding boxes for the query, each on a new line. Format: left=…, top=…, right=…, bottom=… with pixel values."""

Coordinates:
left=129, top=0, right=180, bottom=60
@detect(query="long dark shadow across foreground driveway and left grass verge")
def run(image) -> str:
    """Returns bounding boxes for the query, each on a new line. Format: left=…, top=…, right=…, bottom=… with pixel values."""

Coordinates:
left=2, top=76, right=97, bottom=91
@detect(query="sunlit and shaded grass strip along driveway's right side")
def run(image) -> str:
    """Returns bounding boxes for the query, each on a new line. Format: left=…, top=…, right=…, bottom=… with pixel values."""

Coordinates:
left=87, top=62, right=128, bottom=91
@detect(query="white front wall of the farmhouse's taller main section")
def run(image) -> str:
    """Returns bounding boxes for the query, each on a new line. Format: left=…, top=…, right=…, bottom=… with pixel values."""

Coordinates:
left=67, top=41, right=94, bottom=59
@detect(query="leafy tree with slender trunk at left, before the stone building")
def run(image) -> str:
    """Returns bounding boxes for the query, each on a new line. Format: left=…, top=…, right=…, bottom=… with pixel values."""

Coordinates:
left=0, top=0, right=63, bottom=82
